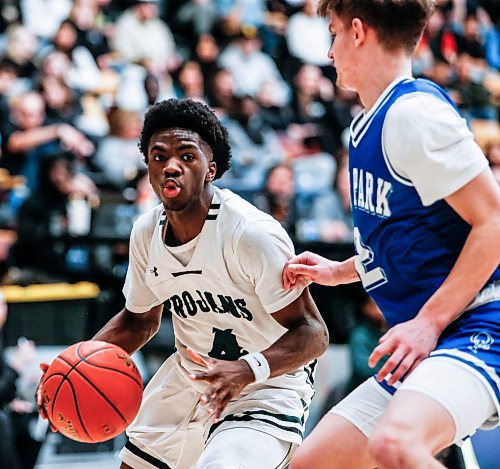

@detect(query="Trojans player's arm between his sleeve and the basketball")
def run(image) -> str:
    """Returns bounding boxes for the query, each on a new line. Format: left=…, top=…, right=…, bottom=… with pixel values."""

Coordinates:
left=92, top=305, right=163, bottom=354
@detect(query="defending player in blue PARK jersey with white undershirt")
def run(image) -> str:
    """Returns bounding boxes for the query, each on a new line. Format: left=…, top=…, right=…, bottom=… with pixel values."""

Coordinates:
left=283, top=0, right=500, bottom=469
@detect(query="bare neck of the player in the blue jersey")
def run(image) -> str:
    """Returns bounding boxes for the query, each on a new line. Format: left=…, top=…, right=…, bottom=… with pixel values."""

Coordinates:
left=357, top=50, right=411, bottom=112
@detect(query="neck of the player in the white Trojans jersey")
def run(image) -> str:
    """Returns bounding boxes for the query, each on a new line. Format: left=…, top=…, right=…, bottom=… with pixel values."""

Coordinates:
left=164, top=186, right=214, bottom=246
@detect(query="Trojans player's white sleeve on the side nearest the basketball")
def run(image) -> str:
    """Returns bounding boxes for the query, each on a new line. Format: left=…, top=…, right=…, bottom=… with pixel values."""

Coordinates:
left=123, top=219, right=161, bottom=313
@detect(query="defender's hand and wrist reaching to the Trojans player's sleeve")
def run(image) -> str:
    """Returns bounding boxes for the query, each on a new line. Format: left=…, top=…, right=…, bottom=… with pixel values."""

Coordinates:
left=283, top=251, right=359, bottom=289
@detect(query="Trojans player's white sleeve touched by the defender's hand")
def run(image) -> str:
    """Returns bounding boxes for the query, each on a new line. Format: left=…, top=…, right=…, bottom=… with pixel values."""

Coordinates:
left=236, top=220, right=304, bottom=313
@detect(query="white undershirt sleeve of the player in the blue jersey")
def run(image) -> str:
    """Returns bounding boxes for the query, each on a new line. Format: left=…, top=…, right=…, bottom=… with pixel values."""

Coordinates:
left=382, top=93, right=488, bottom=205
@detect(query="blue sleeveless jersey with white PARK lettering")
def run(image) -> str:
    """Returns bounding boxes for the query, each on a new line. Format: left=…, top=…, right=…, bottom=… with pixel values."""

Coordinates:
left=349, top=79, right=500, bottom=326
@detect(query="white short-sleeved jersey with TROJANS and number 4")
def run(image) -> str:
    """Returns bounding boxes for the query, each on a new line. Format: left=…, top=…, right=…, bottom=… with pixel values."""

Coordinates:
left=124, top=187, right=302, bottom=372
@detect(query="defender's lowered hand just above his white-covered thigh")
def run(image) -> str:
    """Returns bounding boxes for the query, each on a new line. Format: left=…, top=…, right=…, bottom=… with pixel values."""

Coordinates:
left=368, top=317, right=440, bottom=385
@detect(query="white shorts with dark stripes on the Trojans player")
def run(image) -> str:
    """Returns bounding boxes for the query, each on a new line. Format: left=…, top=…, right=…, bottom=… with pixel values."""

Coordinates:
left=120, top=354, right=312, bottom=469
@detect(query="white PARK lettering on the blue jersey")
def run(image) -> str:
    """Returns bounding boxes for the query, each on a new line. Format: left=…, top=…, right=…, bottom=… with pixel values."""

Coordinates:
left=351, top=168, right=392, bottom=218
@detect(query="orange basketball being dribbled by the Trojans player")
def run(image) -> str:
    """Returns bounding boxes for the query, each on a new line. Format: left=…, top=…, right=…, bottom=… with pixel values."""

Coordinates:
left=41, top=340, right=143, bottom=443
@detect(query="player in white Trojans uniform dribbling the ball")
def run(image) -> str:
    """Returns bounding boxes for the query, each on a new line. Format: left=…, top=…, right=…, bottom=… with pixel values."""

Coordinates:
left=79, top=99, right=328, bottom=469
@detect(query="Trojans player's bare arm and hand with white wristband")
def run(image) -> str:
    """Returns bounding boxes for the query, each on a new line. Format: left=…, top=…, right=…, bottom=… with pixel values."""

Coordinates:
left=188, top=289, right=328, bottom=419
